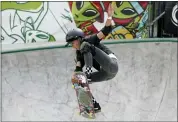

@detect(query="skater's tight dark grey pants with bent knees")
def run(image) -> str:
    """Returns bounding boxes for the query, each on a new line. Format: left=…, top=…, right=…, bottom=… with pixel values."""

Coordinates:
left=80, top=42, right=118, bottom=82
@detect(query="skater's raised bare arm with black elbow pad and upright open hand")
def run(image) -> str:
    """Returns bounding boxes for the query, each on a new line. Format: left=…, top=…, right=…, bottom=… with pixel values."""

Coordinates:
left=97, top=4, right=114, bottom=40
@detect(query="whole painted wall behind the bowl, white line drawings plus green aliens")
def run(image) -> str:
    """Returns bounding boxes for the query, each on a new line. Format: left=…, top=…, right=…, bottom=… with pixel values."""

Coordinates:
left=1, top=1, right=148, bottom=44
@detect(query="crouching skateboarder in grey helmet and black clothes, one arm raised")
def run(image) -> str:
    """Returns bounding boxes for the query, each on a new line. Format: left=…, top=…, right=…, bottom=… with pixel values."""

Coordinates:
left=66, top=5, right=118, bottom=112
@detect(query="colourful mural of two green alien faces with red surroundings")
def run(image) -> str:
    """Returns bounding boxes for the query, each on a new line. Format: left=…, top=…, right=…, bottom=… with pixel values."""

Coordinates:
left=69, top=1, right=148, bottom=39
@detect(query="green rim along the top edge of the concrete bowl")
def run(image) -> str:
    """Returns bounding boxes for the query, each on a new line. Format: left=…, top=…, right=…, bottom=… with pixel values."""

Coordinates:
left=1, top=38, right=178, bottom=54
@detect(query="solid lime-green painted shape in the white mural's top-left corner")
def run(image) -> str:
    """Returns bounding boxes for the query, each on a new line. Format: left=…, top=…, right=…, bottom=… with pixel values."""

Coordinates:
left=1, top=1, right=43, bottom=12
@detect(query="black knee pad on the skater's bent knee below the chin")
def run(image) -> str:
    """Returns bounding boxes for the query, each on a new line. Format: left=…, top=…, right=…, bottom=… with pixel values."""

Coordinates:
left=80, top=42, right=95, bottom=55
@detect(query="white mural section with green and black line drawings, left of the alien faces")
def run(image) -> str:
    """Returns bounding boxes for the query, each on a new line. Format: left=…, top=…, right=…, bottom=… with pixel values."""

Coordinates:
left=1, top=1, right=73, bottom=44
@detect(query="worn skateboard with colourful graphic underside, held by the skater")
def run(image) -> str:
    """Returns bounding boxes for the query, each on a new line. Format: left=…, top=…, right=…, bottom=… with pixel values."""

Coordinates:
left=72, top=72, right=95, bottom=119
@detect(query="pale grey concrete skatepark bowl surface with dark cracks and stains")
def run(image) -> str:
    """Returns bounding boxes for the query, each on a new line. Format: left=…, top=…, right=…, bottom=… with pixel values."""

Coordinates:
left=1, top=38, right=177, bottom=121
